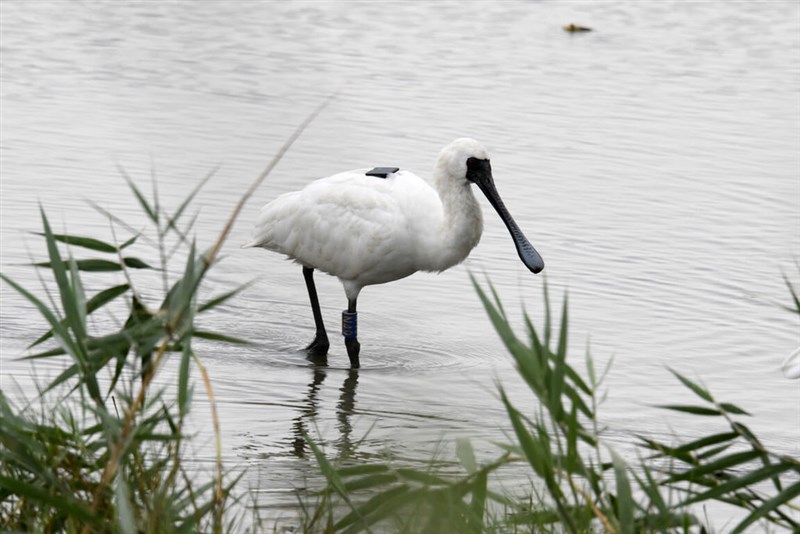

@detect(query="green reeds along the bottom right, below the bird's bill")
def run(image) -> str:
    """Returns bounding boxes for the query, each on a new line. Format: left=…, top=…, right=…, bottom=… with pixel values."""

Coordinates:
left=306, top=279, right=800, bottom=533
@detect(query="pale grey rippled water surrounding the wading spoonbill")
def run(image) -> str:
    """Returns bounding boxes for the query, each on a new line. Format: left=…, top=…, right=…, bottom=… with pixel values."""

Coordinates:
left=0, top=1, right=800, bottom=528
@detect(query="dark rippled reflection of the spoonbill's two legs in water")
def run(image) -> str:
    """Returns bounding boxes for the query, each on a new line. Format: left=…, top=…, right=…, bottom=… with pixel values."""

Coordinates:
left=292, top=357, right=358, bottom=458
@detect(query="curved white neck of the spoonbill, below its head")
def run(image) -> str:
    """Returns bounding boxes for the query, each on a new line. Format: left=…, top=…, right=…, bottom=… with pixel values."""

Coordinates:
left=422, top=169, right=483, bottom=271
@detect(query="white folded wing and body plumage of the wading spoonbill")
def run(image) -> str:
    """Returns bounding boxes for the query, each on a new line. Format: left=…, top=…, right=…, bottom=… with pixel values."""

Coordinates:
left=249, top=171, right=438, bottom=285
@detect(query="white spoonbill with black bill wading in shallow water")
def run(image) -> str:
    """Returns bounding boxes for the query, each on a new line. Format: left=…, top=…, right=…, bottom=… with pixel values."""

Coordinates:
left=245, top=139, right=544, bottom=368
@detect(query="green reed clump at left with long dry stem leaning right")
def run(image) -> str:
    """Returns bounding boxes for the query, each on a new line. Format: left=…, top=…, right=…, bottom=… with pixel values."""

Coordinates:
left=0, top=99, right=330, bottom=533
